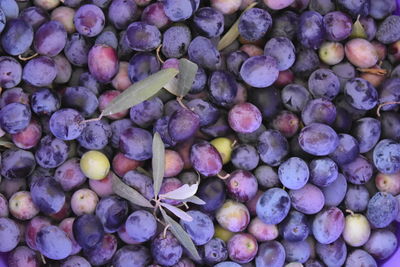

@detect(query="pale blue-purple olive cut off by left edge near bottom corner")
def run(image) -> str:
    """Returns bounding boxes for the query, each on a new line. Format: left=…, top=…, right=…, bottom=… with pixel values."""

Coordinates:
left=0, top=218, right=20, bottom=252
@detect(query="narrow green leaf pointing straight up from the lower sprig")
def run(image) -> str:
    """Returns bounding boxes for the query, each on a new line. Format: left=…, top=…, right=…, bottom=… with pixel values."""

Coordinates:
left=151, top=132, right=165, bottom=196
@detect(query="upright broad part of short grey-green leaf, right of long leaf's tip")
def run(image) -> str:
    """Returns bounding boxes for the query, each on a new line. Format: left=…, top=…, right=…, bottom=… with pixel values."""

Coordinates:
left=178, top=58, right=199, bottom=97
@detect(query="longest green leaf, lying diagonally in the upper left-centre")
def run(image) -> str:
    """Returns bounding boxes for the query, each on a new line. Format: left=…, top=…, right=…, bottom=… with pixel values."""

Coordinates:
left=101, top=68, right=179, bottom=116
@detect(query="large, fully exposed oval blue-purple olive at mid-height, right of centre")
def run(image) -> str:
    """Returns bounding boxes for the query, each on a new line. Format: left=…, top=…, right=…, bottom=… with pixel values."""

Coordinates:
left=299, top=123, right=339, bottom=156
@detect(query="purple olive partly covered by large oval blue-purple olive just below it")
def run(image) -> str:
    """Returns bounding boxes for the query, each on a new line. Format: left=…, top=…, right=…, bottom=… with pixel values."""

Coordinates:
left=301, top=98, right=336, bottom=125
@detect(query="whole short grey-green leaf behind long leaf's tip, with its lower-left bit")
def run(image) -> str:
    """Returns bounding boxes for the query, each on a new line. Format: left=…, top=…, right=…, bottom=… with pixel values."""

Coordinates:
left=164, top=58, right=198, bottom=97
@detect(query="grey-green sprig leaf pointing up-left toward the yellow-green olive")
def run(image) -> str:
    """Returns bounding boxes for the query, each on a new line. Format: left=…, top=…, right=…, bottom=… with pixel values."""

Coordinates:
left=111, top=175, right=153, bottom=208
